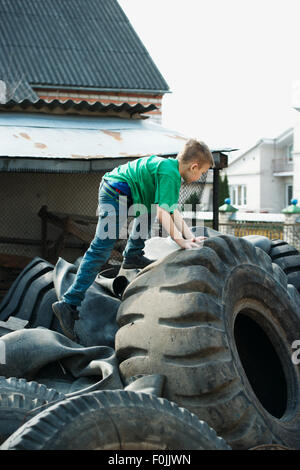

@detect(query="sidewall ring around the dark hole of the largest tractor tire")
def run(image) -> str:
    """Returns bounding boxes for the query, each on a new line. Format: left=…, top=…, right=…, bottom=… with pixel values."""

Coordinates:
left=222, top=265, right=300, bottom=446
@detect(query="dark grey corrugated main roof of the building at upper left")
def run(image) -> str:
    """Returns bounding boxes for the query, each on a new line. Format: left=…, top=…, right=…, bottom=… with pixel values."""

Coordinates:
left=0, top=0, right=169, bottom=92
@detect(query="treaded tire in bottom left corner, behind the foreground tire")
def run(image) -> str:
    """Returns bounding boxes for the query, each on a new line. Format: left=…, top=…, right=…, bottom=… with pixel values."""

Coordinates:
left=0, top=377, right=65, bottom=443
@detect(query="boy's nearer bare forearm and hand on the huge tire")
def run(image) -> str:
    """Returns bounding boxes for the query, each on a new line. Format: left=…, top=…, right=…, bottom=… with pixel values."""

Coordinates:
left=157, top=206, right=199, bottom=249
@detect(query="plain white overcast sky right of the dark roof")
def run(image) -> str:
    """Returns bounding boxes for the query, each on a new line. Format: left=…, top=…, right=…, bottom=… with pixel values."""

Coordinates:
left=119, top=0, right=300, bottom=156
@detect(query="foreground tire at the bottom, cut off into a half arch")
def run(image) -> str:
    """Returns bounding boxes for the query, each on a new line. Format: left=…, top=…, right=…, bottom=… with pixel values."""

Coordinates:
left=1, top=390, right=230, bottom=450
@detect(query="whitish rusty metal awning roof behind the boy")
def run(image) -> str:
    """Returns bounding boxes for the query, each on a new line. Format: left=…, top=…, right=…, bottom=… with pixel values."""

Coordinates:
left=0, top=113, right=230, bottom=172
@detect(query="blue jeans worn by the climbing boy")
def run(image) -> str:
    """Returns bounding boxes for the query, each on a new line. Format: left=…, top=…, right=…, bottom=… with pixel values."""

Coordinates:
left=62, top=183, right=152, bottom=306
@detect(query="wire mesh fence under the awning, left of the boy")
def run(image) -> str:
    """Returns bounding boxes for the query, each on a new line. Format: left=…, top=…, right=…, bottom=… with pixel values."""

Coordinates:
left=0, top=173, right=103, bottom=259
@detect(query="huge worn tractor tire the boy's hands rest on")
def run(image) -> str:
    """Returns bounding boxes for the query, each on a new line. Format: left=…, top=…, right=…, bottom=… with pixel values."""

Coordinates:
left=116, top=235, right=300, bottom=449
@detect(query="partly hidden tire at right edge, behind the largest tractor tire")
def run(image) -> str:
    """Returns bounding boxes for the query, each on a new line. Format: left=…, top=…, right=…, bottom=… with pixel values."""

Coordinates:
left=269, top=239, right=300, bottom=293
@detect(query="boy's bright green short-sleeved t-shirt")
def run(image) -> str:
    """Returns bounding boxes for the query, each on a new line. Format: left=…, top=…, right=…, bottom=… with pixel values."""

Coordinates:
left=103, top=155, right=181, bottom=213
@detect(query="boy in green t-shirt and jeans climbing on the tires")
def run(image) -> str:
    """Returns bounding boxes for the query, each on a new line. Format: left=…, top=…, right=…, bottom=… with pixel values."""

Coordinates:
left=52, top=139, right=214, bottom=340
